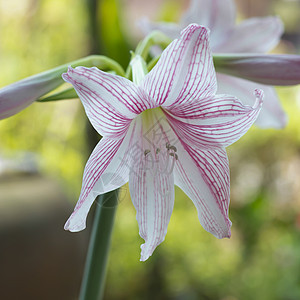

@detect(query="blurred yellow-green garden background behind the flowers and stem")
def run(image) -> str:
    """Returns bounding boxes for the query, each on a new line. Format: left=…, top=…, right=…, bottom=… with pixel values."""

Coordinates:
left=0, top=0, right=300, bottom=300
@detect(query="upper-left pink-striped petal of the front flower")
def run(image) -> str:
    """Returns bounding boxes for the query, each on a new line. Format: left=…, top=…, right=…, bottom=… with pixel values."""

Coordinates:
left=63, top=67, right=151, bottom=138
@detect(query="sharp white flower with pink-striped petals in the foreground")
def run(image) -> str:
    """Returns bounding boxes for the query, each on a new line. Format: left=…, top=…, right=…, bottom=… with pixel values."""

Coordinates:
left=63, top=24, right=262, bottom=261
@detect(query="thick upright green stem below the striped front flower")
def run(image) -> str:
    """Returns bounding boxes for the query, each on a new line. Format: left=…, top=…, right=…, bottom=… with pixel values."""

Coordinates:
left=79, top=191, right=118, bottom=300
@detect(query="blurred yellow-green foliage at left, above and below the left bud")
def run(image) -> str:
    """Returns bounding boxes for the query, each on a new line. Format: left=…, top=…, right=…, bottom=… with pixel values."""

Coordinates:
left=0, top=0, right=89, bottom=196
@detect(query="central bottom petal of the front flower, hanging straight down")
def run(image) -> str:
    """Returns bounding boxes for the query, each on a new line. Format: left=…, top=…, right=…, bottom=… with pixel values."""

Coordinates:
left=129, top=108, right=176, bottom=261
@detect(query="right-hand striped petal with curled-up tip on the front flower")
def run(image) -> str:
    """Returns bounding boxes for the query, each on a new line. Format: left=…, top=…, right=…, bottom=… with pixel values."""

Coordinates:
left=167, top=90, right=263, bottom=150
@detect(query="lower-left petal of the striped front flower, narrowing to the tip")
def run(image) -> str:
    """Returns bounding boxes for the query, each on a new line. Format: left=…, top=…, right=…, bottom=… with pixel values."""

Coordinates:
left=65, top=123, right=136, bottom=231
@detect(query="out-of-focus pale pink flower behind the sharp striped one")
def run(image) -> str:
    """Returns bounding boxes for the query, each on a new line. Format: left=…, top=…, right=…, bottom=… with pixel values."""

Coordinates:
left=140, top=0, right=287, bottom=128
